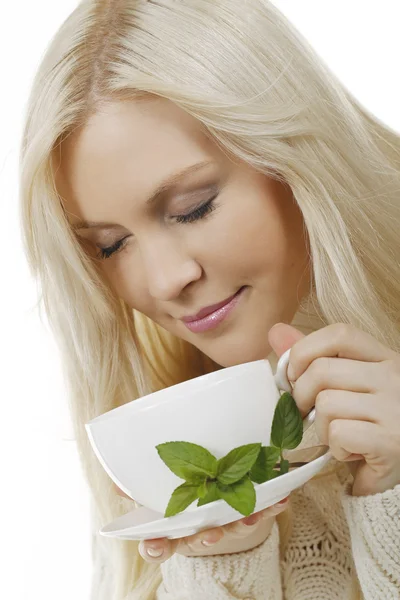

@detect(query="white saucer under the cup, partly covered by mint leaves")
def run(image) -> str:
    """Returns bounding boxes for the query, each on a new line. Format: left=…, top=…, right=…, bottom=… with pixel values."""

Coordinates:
left=99, top=451, right=332, bottom=540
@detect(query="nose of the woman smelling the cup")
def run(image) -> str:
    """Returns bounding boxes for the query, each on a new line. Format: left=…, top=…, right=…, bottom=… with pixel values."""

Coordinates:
left=141, top=235, right=202, bottom=301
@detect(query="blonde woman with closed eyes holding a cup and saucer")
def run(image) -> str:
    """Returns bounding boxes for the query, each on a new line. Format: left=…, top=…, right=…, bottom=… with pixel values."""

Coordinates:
left=21, top=0, right=400, bottom=600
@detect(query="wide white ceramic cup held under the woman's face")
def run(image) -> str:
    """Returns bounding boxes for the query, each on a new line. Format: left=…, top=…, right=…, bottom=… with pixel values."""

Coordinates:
left=85, top=349, right=315, bottom=514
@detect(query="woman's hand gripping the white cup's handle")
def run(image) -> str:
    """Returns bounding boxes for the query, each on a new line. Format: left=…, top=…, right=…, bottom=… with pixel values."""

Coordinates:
left=268, top=323, right=400, bottom=496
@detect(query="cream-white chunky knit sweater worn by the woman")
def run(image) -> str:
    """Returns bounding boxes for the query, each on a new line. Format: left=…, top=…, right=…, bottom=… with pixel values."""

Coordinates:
left=157, top=314, right=400, bottom=600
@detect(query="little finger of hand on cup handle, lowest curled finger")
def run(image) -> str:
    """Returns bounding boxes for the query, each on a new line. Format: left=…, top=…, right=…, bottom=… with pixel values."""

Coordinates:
left=329, top=419, right=399, bottom=466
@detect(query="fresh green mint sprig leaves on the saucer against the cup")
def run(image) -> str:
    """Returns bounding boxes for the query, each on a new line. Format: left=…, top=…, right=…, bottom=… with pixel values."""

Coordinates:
left=156, top=392, right=303, bottom=517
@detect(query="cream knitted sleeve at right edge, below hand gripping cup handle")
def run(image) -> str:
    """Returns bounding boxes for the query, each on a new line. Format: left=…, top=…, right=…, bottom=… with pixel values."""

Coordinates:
left=341, top=482, right=400, bottom=600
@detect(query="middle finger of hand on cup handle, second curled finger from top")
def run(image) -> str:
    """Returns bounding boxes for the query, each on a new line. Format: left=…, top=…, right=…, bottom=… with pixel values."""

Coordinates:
left=292, top=356, right=386, bottom=418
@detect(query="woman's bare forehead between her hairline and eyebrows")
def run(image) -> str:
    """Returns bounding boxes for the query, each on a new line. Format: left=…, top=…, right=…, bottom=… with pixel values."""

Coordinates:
left=55, top=99, right=222, bottom=220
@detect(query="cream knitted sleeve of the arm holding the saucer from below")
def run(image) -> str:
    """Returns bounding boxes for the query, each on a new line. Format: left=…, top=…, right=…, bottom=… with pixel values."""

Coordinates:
left=157, top=522, right=283, bottom=600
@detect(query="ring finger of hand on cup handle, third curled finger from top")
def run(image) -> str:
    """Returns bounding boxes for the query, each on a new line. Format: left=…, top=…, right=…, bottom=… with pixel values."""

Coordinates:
left=315, top=389, right=385, bottom=444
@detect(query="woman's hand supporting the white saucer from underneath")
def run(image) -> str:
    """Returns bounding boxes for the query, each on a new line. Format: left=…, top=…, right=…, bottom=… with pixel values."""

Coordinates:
left=116, top=486, right=289, bottom=563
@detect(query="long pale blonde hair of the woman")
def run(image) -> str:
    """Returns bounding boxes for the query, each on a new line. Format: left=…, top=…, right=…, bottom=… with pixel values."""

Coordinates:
left=20, top=0, right=400, bottom=600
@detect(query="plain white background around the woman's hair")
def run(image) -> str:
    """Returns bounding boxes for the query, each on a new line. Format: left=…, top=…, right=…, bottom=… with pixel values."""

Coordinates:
left=0, top=0, right=400, bottom=600
